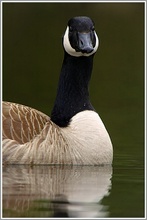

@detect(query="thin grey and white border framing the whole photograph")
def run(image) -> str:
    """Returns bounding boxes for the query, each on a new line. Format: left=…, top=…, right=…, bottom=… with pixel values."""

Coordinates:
left=0, top=0, right=147, bottom=220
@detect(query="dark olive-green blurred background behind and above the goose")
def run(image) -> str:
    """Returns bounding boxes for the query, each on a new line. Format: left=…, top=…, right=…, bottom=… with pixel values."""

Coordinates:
left=3, top=2, right=144, bottom=163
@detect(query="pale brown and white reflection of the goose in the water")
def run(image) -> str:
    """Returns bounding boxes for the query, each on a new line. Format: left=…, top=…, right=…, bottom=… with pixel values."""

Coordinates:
left=3, top=166, right=112, bottom=217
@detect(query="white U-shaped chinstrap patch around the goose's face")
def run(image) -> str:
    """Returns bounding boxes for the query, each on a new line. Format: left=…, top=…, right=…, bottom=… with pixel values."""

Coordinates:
left=63, top=26, right=99, bottom=57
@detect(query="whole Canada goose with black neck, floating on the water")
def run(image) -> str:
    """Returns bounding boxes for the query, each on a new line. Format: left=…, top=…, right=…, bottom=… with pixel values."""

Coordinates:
left=3, top=17, right=113, bottom=165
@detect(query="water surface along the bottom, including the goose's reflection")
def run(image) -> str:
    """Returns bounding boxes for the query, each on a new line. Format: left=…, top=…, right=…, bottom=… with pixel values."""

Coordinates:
left=3, top=158, right=144, bottom=218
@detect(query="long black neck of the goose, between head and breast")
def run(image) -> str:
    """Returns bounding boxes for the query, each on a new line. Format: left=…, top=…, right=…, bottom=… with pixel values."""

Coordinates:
left=51, top=52, right=94, bottom=127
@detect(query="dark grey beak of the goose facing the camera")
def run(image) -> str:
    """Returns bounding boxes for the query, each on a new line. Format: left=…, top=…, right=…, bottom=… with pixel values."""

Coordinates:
left=76, top=32, right=94, bottom=54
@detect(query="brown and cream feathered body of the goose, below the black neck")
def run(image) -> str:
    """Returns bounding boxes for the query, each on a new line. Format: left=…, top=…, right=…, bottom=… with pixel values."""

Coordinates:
left=3, top=102, right=112, bottom=165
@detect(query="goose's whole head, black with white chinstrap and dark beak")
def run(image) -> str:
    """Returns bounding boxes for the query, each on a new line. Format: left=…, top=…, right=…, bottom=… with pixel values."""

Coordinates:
left=63, top=17, right=99, bottom=57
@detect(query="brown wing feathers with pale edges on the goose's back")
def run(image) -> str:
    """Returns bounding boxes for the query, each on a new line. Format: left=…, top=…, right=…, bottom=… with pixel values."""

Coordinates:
left=3, top=102, right=50, bottom=144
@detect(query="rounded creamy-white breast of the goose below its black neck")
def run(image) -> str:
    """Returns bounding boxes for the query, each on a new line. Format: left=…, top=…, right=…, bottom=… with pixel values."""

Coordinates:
left=62, top=110, right=113, bottom=164
